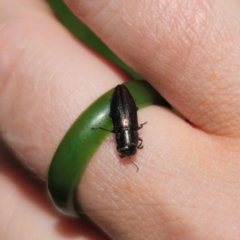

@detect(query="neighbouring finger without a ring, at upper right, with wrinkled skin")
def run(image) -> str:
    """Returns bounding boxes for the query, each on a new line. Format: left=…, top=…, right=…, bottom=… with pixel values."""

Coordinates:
left=66, top=0, right=240, bottom=136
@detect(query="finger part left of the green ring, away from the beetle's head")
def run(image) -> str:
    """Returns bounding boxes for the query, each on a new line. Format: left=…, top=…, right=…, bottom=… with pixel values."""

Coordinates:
left=0, top=0, right=126, bottom=179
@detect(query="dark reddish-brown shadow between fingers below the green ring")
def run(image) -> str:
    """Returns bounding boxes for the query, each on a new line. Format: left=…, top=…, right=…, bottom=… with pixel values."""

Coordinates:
left=0, top=139, right=110, bottom=240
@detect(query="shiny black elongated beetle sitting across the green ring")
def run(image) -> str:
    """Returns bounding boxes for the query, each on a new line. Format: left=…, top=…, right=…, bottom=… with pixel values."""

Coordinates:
left=92, top=85, right=147, bottom=171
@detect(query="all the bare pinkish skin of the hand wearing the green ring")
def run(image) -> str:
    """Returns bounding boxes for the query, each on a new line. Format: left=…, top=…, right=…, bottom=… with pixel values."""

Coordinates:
left=0, top=0, right=240, bottom=240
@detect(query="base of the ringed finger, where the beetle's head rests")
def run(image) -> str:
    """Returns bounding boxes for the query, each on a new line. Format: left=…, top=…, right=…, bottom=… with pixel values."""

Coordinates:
left=78, top=107, right=240, bottom=240
